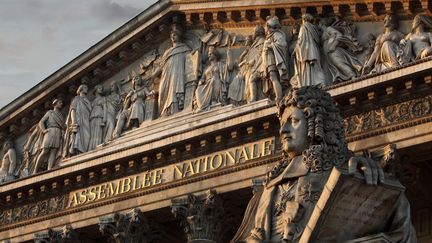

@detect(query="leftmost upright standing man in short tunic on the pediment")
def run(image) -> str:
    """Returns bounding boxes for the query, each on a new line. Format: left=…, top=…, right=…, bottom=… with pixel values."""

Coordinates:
left=32, top=99, right=66, bottom=174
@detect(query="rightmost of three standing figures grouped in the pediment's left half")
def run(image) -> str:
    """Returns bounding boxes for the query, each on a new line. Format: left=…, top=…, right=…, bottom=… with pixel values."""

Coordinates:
left=103, top=82, right=122, bottom=143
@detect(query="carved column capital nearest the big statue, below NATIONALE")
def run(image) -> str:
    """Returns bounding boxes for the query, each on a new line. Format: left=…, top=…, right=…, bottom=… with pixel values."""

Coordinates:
left=171, top=190, right=224, bottom=243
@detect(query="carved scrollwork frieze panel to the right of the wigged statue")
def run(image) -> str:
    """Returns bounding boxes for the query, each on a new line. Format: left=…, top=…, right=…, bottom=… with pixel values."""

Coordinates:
left=344, top=95, right=432, bottom=136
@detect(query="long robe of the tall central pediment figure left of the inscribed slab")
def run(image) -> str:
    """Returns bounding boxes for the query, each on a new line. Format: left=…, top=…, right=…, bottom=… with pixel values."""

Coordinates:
left=158, top=43, right=191, bottom=116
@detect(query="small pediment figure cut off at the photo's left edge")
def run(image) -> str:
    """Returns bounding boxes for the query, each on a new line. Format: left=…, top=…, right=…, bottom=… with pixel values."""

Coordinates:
left=0, top=140, right=18, bottom=183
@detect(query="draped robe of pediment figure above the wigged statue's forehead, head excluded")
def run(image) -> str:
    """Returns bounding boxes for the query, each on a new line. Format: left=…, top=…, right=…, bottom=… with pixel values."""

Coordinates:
left=261, top=31, right=289, bottom=93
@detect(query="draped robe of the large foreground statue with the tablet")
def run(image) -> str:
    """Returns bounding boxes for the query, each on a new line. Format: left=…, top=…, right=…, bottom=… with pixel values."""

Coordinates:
left=231, top=156, right=416, bottom=243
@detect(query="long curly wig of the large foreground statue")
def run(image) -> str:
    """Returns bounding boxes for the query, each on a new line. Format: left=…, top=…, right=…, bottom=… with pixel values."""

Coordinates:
left=267, top=86, right=352, bottom=181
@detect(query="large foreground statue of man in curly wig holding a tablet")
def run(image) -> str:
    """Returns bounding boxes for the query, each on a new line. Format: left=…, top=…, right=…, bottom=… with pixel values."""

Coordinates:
left=231, top=86, right=416, bottom=243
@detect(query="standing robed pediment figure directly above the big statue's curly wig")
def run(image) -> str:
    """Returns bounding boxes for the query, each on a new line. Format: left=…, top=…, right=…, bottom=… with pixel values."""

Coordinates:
left=291, top=13, right=325, bottom=87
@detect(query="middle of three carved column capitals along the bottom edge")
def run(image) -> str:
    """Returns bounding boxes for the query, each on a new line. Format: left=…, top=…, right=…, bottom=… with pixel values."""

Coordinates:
left=99, top=208, right=150, bottom=243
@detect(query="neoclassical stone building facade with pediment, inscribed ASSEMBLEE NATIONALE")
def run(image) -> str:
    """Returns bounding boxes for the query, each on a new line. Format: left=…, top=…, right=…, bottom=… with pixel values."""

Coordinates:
left=0, top=0, right=432, bottom=243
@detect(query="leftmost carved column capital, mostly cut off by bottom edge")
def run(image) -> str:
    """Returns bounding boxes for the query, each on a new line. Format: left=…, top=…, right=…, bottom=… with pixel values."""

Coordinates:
left=34, top=225, right=81, bottom=243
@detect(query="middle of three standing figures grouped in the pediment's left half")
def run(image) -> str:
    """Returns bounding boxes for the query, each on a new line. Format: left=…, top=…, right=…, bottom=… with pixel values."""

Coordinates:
left=88, top=84, right=108, bottom=151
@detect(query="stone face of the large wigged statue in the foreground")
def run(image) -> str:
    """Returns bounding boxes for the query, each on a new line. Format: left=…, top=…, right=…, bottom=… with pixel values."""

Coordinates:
left=280, top=107, right=308, bottom=157
